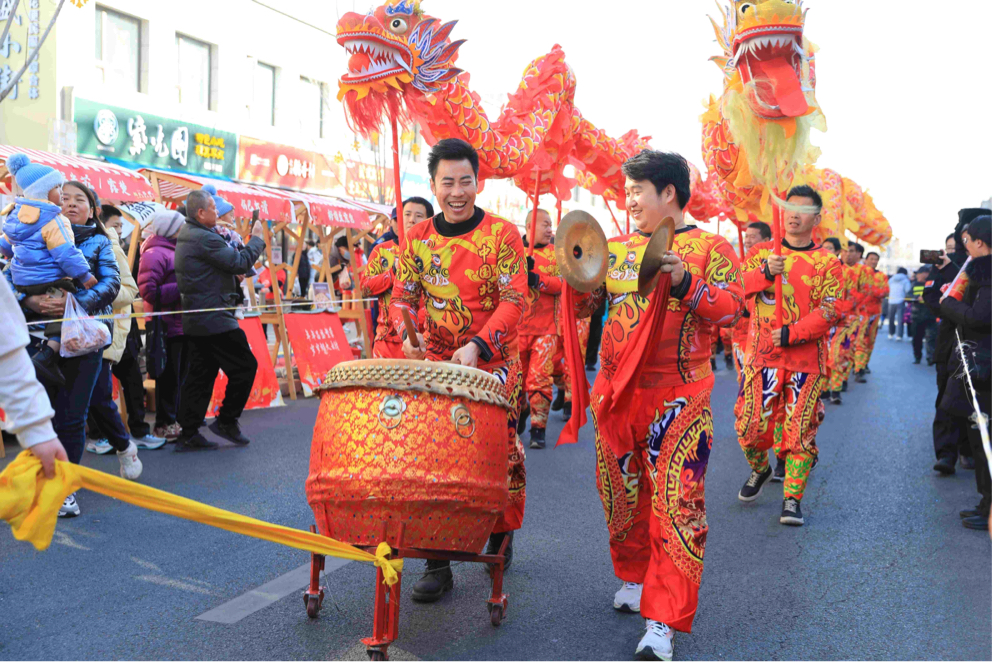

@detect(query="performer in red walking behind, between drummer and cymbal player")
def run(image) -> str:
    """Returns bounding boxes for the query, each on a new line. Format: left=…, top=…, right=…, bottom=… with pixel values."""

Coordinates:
left=517, top=209, right=562, bottom=449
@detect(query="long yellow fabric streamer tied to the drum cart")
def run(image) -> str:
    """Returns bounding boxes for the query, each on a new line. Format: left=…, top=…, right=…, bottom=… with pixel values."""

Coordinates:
left=0, top=451, right=403, bottom=586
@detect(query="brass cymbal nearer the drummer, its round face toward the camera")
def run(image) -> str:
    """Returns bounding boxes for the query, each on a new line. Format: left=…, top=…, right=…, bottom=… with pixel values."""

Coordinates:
left=555, top=210, right=609, bottom=292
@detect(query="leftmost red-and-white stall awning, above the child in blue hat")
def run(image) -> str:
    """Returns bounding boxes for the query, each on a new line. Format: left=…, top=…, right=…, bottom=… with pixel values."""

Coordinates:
left=0, top=145, right=155, bottom=202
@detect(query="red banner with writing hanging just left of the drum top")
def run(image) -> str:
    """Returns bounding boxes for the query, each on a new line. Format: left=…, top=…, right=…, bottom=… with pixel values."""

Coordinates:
left=286, top=313, right=354, bottom=397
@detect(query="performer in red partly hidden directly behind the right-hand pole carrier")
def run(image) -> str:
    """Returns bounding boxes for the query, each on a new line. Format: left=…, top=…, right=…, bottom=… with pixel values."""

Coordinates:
left=823, top=237, right=861, bottom=405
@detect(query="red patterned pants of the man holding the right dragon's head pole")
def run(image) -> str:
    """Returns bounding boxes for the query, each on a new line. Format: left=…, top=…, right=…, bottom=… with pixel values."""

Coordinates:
left=734, top=365, right=826, bottom=500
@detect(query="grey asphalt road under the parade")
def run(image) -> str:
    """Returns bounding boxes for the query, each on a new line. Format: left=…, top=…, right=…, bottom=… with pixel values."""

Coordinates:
left=0, top=337, right=992, bottom=660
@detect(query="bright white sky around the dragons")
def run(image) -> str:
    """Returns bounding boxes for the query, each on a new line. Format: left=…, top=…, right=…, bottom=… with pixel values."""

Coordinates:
left=323, top=0, right=992, bottom=249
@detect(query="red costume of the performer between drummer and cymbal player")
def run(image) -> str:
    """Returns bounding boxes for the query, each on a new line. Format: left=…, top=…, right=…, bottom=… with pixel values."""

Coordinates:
left=519, top=244, right=562, bottom=430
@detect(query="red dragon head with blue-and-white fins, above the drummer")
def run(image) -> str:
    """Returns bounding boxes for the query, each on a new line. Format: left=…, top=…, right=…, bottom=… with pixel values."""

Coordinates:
left=337, top=0, right=464, bottom=135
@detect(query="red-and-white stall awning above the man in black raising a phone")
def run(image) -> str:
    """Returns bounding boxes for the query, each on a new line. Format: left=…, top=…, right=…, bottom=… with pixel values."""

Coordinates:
left=138, top=168, right=295, bottom=222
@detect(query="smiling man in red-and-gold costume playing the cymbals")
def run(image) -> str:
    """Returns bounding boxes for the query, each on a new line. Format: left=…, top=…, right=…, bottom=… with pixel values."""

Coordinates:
left=575, top=150, right=743, bottom=660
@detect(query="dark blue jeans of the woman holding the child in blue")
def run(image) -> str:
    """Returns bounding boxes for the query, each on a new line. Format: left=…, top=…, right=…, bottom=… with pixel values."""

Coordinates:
left=48, top=350, right=103, bottom=464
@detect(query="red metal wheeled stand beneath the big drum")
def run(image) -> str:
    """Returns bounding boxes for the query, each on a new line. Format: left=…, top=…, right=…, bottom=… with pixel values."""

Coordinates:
left=303, top=522, right=510, bottom=660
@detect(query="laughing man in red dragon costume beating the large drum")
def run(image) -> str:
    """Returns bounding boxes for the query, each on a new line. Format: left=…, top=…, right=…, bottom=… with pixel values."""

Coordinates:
left=389, top=138, right=527, bottom=602
